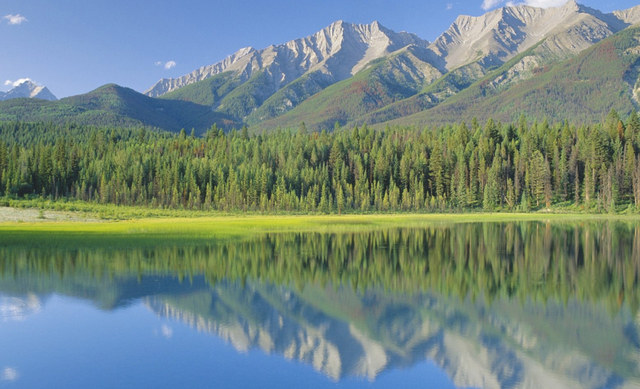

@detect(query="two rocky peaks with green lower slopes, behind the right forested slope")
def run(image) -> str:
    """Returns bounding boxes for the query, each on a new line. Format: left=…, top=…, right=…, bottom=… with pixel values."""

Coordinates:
left=140, top=0, right=640, bottom=130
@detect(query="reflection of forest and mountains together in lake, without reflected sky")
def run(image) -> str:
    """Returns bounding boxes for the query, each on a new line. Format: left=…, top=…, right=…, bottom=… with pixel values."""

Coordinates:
left=0, top=222, right=640, bottom=388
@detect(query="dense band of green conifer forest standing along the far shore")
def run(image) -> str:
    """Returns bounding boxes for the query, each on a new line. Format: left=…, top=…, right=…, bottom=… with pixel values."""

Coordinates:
left=0, top=111, right=640, bottom=213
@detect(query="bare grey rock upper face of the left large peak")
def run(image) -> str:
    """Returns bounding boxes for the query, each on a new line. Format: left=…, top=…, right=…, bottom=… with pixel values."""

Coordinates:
left=145, top=21, right=428, bottom=97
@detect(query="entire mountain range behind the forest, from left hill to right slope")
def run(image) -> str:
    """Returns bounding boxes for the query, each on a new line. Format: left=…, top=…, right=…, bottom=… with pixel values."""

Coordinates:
left=0, top=0, right=640, bottom=132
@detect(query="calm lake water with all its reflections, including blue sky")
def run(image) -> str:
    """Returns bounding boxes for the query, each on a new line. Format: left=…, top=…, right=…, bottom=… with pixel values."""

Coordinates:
left=0, top=221, right=640, bottom=388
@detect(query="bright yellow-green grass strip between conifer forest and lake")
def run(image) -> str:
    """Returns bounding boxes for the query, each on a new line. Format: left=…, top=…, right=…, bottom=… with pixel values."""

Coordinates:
left=0, top=208, right=640, bottom=245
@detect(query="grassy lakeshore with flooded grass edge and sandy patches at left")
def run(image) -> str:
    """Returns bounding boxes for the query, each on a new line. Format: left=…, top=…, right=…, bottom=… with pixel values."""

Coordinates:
left=0, top=208, right=640, bottom=250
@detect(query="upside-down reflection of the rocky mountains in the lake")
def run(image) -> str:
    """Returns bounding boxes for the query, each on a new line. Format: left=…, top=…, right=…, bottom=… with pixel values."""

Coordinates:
left=145, top=283, right=640, bottom=388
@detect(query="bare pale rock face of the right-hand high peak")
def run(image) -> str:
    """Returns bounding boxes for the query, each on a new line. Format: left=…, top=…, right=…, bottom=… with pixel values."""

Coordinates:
left=430, top=0, right=626, bottom=70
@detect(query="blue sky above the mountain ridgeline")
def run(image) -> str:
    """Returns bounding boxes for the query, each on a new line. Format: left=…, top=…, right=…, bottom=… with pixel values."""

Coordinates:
left=0, top=0, right=638, bottom=97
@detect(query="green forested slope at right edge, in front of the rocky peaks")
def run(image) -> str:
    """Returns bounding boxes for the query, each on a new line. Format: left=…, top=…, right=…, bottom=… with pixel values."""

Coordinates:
left=384, top=27, right=640, bottom=125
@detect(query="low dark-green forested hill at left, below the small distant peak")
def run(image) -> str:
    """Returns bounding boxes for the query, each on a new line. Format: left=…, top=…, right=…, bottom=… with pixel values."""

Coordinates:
left=0, top=84, right=235, bottom=133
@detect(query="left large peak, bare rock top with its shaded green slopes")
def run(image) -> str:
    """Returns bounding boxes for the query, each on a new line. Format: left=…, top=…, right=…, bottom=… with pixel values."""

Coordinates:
left=145, top=21, right=428, bottom=124
